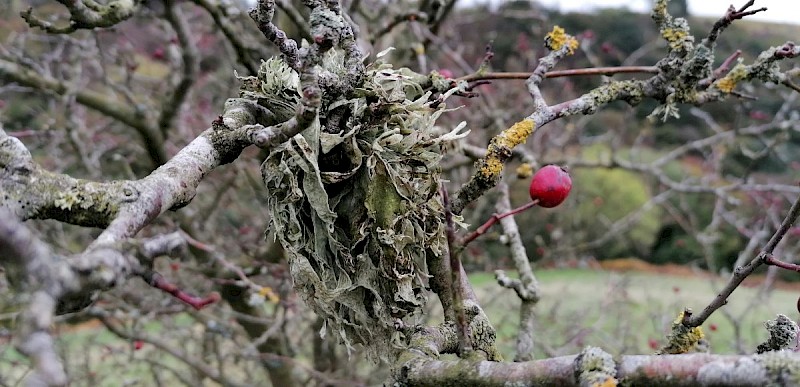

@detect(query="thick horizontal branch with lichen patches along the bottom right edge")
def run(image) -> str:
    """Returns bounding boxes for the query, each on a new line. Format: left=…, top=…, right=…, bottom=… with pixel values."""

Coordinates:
left=394, top=351, right=800, bottom=387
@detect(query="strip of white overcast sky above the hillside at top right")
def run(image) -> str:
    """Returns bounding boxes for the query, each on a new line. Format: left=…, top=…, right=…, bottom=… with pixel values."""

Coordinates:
left=528, top=0, right=800, bottom=24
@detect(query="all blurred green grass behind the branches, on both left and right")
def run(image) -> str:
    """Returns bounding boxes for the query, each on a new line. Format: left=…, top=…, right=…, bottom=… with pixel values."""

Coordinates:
left=0, top=269, right=797, bottom=386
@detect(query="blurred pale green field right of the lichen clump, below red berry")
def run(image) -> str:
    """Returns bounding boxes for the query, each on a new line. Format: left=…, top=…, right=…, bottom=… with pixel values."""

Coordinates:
left=478, top=269, right=798, bottom=357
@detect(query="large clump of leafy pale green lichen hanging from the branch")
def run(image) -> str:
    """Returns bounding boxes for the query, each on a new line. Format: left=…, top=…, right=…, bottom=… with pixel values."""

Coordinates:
left=260, top=54, right=464, bottom=357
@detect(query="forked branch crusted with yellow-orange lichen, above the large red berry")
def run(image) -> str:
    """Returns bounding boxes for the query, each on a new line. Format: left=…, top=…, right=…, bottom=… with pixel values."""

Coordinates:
left=453, top=0, right=800, bottom=214
